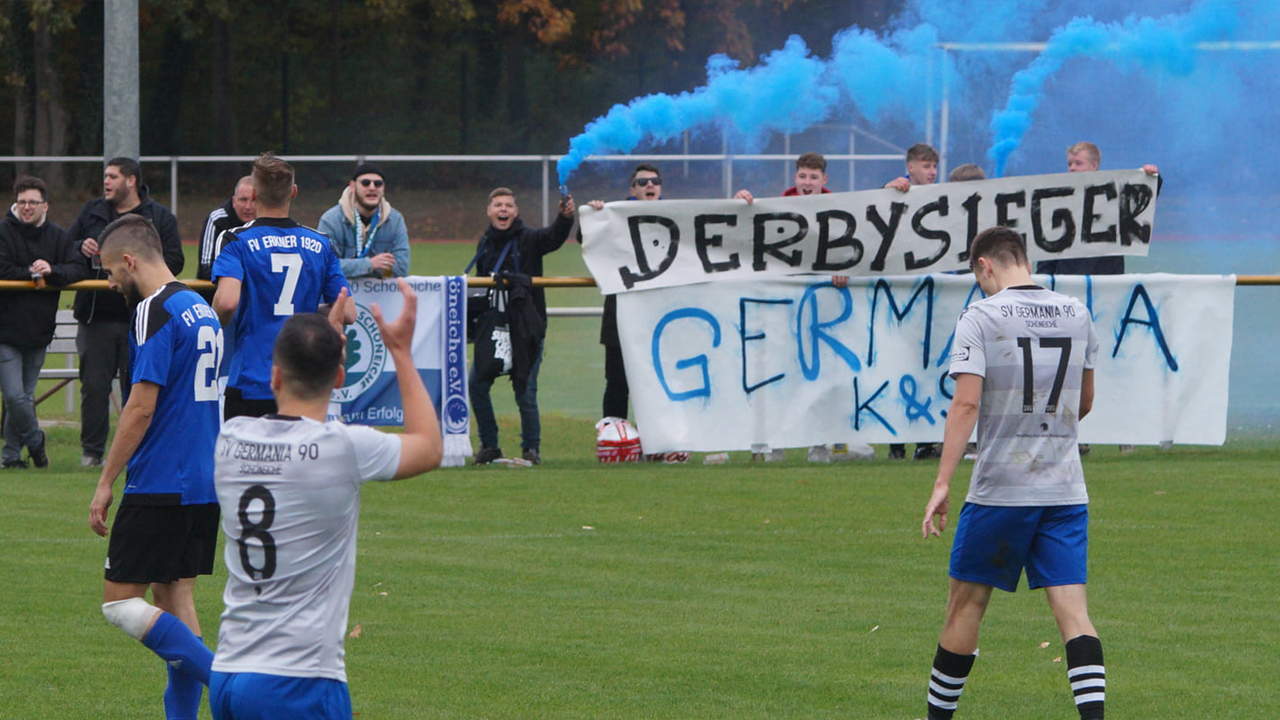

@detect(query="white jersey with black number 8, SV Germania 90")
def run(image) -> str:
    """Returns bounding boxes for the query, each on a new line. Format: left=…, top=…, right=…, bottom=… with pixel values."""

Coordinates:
left=214, top=416, right=401, bottom=682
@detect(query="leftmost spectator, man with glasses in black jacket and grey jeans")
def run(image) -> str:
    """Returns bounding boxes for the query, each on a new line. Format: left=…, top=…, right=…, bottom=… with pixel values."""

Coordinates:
left=0, top=177, right=88, bottom=469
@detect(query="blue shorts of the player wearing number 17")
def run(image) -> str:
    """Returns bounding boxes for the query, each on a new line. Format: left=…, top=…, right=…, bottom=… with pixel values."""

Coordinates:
left=950, top=502, right=1089, bottom=592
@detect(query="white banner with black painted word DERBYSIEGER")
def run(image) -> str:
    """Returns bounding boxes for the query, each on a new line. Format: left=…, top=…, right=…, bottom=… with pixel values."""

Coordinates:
left=581, top=170, right=1156, bottom=295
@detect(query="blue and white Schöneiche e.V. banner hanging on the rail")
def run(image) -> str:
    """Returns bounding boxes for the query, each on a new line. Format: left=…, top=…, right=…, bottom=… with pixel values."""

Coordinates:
left=329, top=275, right=471, bottom=466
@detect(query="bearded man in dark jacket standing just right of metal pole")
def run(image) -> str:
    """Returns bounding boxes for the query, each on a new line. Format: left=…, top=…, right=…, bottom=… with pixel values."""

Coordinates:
left=70, top=158, right=186, bottom=466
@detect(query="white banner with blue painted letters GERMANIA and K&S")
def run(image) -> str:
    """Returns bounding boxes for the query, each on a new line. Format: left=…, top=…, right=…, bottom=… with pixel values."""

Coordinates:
left=618, top=274, right=1235, bottom=452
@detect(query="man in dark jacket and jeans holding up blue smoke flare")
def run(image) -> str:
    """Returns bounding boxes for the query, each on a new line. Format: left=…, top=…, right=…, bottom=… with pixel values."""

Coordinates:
left=468, top=187, right=573, bottom=465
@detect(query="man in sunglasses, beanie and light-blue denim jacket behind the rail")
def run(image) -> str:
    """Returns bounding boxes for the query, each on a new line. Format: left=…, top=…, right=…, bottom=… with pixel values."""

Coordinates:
left=316, top=163, right=408, bottom=278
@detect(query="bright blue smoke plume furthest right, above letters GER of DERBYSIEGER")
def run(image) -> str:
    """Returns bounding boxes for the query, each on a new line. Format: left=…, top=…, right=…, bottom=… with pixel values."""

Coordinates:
left=987, top=0, right=1239, bottom=177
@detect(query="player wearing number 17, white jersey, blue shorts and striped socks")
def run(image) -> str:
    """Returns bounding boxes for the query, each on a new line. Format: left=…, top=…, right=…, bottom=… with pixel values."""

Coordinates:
left=922, top=227, right=1107, bottom=720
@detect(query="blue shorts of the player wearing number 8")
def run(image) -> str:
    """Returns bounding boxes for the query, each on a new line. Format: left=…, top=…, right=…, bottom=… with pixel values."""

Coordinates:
left=209, top=671, right=351, bottom=720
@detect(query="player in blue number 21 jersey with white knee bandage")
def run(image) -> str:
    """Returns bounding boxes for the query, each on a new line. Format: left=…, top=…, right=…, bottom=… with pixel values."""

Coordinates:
left=88, top=214, right=223, bottom=720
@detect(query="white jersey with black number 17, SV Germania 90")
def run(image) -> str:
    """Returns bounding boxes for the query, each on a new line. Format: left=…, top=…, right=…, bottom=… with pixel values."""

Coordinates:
left=950, top=286, right=1098, bottom=506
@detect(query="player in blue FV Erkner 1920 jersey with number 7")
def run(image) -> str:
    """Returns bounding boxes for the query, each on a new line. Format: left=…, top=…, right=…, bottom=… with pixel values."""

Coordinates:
left=212, top=152, right=356, bottom=420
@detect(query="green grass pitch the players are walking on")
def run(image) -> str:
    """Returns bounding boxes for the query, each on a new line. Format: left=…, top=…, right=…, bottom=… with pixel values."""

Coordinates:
left=0, top=239, right=1280, bottom=720
